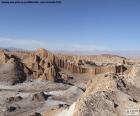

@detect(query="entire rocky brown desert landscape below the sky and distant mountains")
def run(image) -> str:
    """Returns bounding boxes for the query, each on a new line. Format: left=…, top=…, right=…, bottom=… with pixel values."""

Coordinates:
left=0, top=48, right=140, bottom=116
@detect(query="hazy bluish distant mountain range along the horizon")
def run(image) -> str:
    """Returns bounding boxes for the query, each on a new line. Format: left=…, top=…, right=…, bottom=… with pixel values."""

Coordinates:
left=0, top=47, right=140, bottom=58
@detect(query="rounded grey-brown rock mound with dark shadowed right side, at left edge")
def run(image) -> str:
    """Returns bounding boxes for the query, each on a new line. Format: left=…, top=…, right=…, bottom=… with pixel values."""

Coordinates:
left=0, top=51, right=31, bottom=85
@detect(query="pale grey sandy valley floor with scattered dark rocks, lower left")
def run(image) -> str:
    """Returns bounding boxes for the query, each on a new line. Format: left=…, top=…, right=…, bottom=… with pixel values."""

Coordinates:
left=0, top=80, right=83, bottom=116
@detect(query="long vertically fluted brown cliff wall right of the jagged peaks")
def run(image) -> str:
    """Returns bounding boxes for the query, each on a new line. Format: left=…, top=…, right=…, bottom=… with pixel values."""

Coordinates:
left=55, top=55, right=127, bottom=76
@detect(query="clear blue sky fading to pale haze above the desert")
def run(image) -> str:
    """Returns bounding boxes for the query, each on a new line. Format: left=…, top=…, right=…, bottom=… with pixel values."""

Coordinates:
left=0, top=0, right=140, bottom=50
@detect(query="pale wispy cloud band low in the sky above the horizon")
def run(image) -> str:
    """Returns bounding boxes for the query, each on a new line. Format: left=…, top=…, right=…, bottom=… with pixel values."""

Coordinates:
left=0, top=38, right=106, bottom=51
